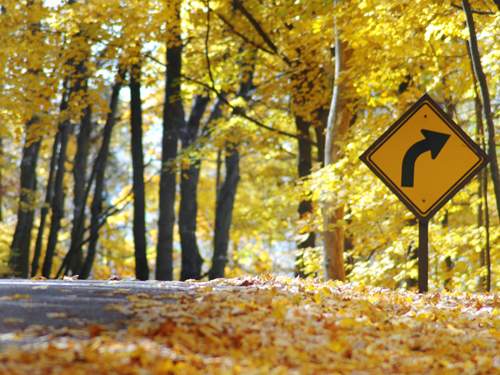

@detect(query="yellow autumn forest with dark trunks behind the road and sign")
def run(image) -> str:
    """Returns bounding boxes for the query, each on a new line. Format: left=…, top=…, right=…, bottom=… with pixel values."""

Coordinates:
left=0, top=0, right=500, bottom=291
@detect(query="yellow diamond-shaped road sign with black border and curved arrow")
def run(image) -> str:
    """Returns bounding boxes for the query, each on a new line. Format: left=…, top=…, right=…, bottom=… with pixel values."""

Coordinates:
left=360, top=94, right=489, bottom=222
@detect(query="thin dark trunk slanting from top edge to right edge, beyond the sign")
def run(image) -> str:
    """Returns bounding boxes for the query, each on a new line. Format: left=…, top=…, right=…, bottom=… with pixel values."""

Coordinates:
left=462, top=0, right=500, bottom=223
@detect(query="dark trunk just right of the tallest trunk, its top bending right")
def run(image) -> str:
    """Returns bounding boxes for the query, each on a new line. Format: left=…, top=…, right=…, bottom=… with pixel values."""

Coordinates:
left=179, top=95, right=210, bottom=281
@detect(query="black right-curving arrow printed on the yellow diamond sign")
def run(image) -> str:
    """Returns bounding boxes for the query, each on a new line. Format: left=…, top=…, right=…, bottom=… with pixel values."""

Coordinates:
left=401, top=129, right=450, bottom=187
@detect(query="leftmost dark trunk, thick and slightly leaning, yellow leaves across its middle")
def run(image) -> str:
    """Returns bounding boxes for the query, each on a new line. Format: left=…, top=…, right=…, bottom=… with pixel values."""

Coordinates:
left=9, top=119, right=41, bottom=278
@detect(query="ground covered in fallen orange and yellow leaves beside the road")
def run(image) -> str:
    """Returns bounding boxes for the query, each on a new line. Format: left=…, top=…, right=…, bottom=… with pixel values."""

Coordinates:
left=0, top=276, right=500, bottom=375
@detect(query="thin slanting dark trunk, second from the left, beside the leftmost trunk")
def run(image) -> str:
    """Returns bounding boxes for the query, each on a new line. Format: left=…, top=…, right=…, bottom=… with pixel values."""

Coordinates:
left=31, top=131, right=60, bottom=277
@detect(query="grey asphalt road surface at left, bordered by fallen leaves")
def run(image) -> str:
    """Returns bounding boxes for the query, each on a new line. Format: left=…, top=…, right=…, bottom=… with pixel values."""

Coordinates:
left=0, top=279, right=189, bottom=348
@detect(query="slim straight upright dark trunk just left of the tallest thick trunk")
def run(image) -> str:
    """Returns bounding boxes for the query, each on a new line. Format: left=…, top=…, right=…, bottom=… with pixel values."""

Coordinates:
left=130, top=60, right=149, bottom=280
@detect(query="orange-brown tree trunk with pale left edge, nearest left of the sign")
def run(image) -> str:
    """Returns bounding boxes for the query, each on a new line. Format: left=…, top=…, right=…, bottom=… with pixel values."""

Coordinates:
left=323, top=36, right=352, bottom=281
